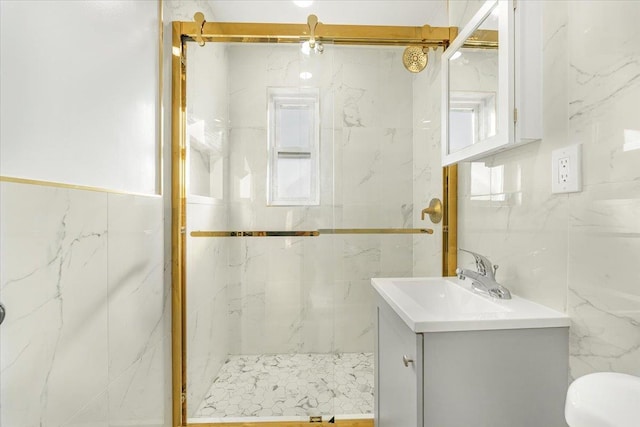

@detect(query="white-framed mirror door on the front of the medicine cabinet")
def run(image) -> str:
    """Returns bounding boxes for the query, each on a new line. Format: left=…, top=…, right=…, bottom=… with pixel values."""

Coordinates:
left=443, top=0, right=509, bottom=165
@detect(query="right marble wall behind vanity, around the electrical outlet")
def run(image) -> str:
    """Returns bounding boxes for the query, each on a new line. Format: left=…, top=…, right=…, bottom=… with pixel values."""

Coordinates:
left=451, top=1, right=640, bottom=378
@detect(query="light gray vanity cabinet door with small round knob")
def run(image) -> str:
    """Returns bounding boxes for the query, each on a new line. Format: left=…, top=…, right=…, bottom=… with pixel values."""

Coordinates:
left=375, top=304, right=422, bottom=427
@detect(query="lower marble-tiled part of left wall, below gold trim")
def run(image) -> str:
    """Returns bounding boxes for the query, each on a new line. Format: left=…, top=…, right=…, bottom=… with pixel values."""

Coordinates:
left=0, top=182, right=165, bottom=427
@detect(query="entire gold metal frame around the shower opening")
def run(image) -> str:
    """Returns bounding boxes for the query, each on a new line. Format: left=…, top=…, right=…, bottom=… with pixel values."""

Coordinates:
left=171, top=14, right=458, bottom=427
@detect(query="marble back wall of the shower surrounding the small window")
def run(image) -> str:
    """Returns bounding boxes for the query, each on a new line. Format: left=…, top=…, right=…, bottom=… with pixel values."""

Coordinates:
left=222, top=45, right=413, bottom=354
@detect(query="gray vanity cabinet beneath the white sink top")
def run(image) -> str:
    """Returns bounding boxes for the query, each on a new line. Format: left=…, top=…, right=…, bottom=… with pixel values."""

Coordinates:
left=375, top=295, right=569, bottom=427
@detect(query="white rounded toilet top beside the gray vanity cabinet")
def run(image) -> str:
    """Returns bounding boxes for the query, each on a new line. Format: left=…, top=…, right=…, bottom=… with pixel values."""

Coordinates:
left=564, top=372, right=640, bottom=427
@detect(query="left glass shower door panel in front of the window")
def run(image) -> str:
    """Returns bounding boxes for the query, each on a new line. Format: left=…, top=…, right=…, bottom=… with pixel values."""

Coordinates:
left=185, top=43, right=334, bottom=423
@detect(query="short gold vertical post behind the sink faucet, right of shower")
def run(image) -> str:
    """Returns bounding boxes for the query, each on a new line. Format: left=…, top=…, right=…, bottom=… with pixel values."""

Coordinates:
left=442, top=165, right=458, bottom=276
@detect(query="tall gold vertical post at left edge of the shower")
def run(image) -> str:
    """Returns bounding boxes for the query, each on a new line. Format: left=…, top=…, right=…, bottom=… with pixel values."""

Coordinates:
left=171, top=22, right=186, bottom=427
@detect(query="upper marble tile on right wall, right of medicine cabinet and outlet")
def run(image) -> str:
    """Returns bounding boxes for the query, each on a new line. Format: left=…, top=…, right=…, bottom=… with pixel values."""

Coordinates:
left=569, top=1, right=640, bottom=185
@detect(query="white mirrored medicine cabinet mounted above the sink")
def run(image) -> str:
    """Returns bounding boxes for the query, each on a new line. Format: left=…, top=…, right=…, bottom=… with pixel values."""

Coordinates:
left=442, top=0, right=542, bottom=166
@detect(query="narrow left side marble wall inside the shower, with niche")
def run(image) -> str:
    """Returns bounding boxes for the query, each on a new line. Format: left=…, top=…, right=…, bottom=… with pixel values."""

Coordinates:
left=185, top=25, right=231, bottom=416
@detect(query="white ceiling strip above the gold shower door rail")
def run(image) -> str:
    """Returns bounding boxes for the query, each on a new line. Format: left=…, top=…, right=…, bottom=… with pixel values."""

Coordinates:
left=208, top=0, right=448, bottom=27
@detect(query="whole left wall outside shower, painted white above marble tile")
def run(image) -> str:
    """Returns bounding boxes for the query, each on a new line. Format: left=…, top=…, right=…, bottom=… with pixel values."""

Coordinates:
left=0, top=1, right=171, bottom=427
